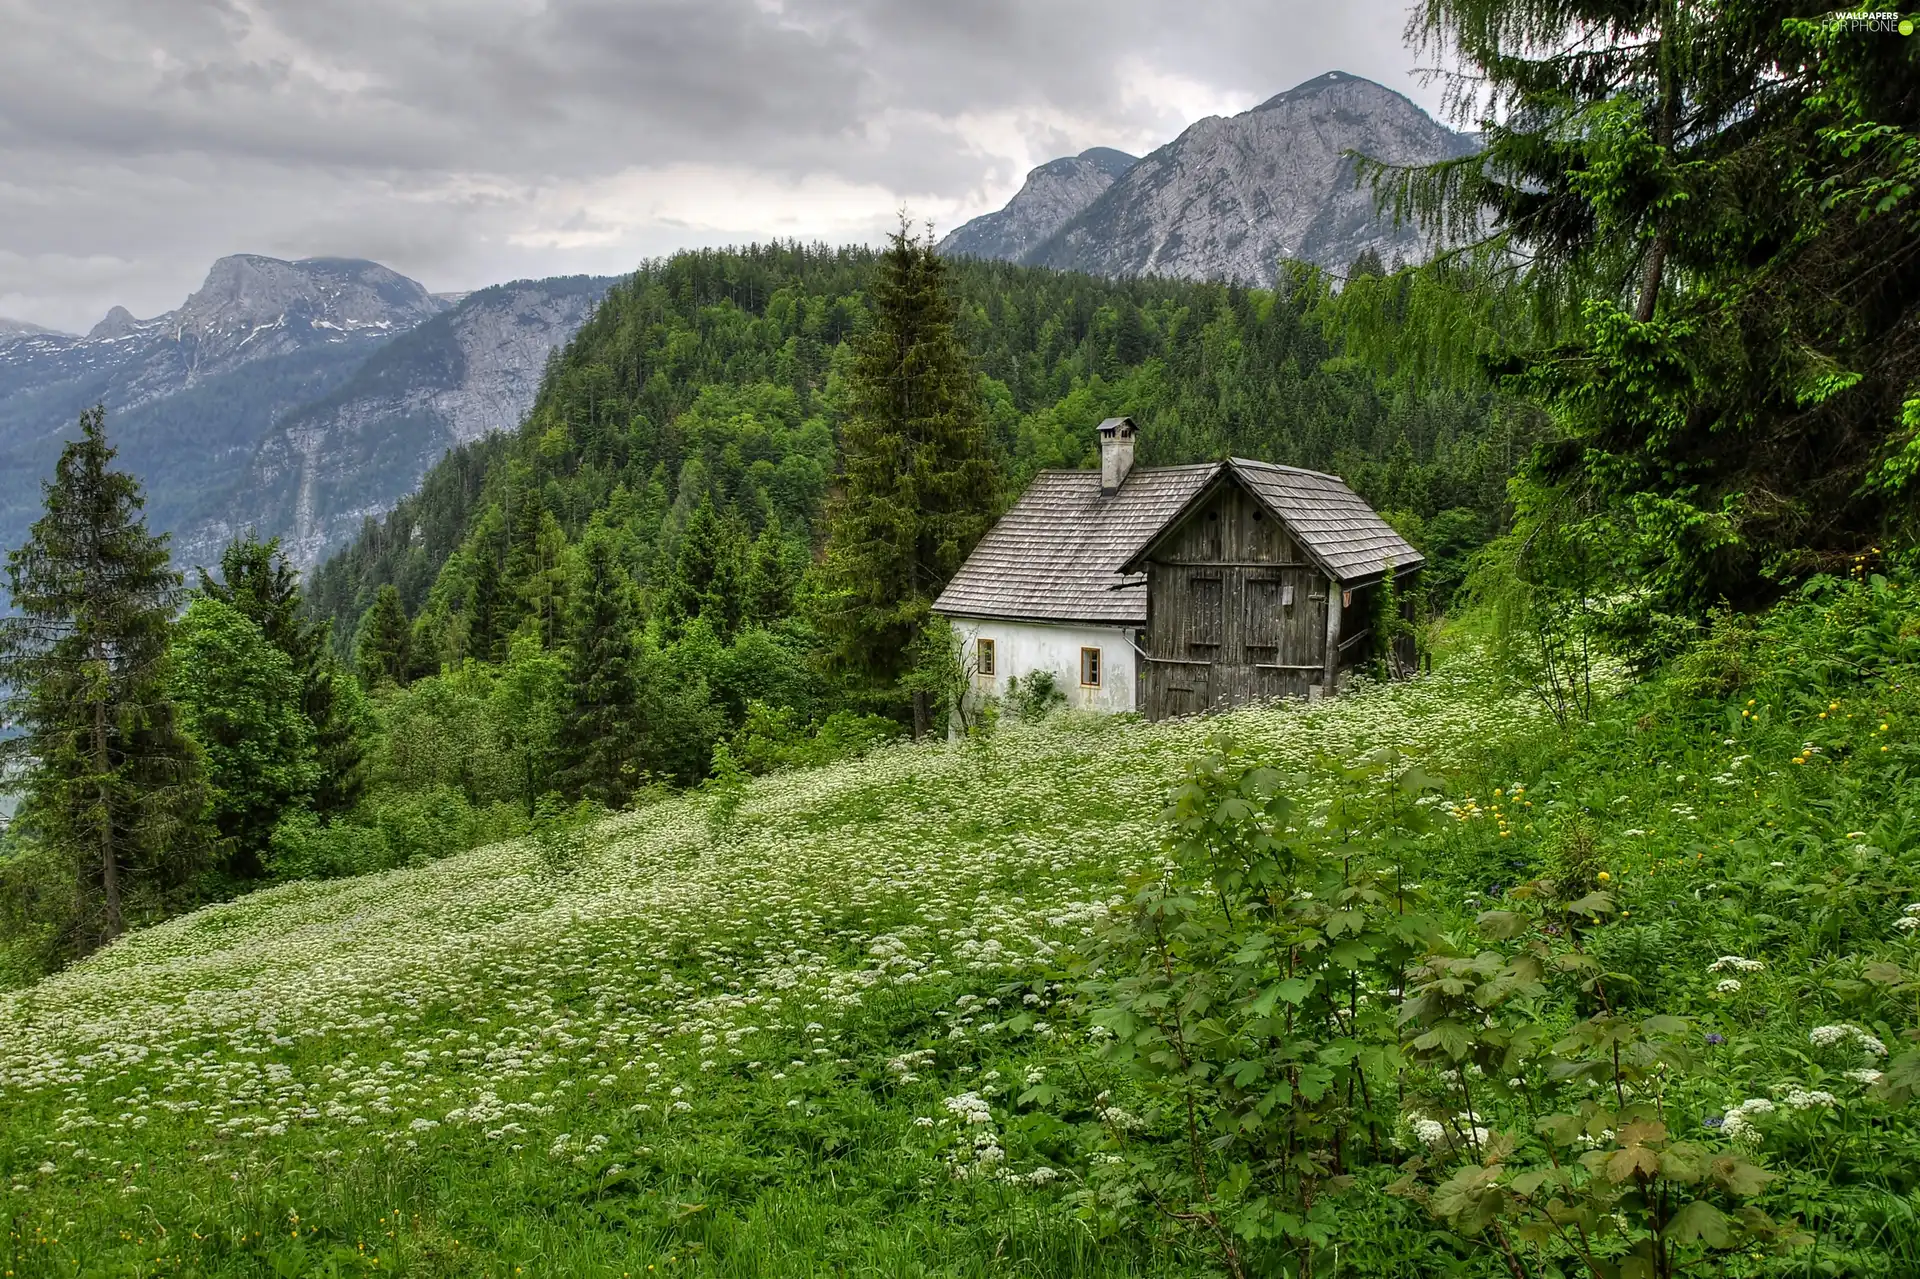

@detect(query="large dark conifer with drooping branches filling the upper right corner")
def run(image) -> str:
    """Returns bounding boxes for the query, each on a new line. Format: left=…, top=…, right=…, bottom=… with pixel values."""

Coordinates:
left=1374, top=0, right=1920, bottom=614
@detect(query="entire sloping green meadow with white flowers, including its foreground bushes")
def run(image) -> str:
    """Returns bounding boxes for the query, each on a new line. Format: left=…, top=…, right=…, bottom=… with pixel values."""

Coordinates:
left=0, top=584, right=1920, bottom=1279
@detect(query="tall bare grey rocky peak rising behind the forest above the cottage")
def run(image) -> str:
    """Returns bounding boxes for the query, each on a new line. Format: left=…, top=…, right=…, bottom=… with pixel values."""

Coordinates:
left=948, top=71, right=1478, bottom=284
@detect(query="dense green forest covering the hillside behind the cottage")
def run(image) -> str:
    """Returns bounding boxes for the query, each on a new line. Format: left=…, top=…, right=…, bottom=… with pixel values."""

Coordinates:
left=311, top=244, right=1540, bottom=653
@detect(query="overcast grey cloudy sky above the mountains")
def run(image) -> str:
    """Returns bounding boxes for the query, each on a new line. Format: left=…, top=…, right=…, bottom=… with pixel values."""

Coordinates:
left=0, top=0, right=1440, bottom=330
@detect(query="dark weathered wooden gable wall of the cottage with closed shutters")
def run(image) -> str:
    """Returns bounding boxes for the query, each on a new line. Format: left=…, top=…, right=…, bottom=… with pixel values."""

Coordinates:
left=1142, top=484, right=1327, bottom=718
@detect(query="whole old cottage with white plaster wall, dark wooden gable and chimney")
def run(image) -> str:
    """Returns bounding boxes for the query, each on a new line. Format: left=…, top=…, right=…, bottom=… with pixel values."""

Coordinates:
left=933, top=417, right=1425, bottom=718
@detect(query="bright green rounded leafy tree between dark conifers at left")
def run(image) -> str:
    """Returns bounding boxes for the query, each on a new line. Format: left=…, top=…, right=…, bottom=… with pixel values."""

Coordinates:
left=167, top=595, right=318, bottom=881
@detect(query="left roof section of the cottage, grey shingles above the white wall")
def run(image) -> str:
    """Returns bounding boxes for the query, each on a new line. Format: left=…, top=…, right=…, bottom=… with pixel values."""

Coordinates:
left=933, top=463, right=1221, bottom=626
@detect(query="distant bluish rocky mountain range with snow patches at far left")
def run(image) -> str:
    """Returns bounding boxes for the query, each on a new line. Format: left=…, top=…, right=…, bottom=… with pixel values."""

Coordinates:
left=0, top=253, right=607, bottom=563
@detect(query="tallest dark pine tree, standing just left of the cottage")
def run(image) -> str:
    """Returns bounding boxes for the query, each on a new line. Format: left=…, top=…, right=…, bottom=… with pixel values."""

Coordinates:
left=822, top=223, right=998, bottom=736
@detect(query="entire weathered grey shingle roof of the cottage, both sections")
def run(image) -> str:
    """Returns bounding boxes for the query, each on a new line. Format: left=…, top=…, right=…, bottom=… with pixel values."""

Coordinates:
left=933, top=457, right=1427, bottom=626
